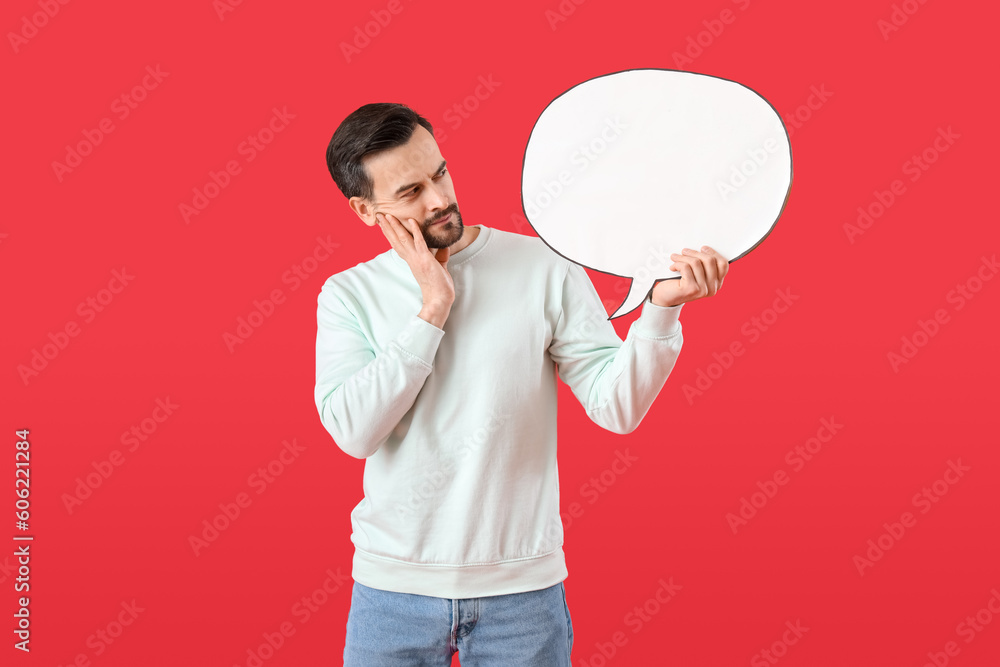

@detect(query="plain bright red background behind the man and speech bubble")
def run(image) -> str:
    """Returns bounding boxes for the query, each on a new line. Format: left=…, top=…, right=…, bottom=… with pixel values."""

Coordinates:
left=0, top=0, right=1000, bottom=667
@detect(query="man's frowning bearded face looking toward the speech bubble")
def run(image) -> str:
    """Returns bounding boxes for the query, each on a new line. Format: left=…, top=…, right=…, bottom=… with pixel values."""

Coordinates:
left=351, top=125, right=464, bottom=248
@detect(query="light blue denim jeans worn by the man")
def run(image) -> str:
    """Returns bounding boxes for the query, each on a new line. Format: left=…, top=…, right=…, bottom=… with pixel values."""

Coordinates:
left=344, top=582, right=573, bottom=667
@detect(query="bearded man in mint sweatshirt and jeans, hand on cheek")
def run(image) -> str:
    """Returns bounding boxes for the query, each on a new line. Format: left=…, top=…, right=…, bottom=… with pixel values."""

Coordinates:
left=315, top=104, right=729, bottom=667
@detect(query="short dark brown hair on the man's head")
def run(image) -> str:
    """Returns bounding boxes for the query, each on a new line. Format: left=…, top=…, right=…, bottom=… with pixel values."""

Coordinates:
left=326, top=102, right=434, bottom=200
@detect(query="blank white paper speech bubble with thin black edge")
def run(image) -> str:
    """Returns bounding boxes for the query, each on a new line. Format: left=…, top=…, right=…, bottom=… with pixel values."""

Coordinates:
left=521, top=69, right=792, bottom=319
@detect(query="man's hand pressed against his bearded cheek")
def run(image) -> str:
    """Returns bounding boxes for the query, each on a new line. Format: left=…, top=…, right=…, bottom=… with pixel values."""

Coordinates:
left=375, top=213, right=455, bottom=329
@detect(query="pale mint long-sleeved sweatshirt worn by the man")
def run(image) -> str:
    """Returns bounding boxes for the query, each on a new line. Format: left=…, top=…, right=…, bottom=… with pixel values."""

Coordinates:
left=315, top=225, right=683, bottom=598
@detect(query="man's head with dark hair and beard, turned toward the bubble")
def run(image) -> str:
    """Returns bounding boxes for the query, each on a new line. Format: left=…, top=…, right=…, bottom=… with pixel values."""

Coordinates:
left=326, top=103, right=463, bottom=248
